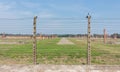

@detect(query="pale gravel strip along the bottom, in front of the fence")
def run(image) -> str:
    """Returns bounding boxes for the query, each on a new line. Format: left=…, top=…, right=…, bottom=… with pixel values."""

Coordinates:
left=0, top=65, right=120, bottom=72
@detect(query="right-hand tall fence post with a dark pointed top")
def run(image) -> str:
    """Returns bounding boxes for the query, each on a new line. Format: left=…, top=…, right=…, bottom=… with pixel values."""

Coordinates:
left=87, top=14, right=91, bottom=65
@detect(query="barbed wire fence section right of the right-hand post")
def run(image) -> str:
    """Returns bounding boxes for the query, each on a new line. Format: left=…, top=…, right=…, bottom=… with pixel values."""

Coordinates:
left=91, top=18, right=120, bottom=65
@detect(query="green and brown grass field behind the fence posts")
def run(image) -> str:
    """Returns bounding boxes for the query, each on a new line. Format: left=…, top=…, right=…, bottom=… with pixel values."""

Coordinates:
left=0, top=38, right=120, bottom=65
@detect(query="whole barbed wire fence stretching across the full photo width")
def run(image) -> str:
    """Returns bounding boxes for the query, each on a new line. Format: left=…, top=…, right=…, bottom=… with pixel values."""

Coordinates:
left=0, top=17, right=120, bottom=65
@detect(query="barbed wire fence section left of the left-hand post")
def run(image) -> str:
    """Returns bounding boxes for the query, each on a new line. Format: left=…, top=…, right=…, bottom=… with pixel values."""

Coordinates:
left=0, top=18, right=33, bottom=64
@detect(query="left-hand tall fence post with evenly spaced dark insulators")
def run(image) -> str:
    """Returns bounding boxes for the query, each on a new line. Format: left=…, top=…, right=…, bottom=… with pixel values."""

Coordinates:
left=33, top=16, right=37, bottom=64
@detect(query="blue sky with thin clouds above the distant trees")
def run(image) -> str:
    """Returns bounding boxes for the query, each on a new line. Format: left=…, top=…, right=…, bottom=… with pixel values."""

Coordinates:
left=0, top=0, right=120, bottom=34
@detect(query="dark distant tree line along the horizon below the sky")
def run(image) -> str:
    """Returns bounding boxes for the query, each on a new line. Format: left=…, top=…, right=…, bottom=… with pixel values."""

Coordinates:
left=0, top=33, right=120, bottom=38
